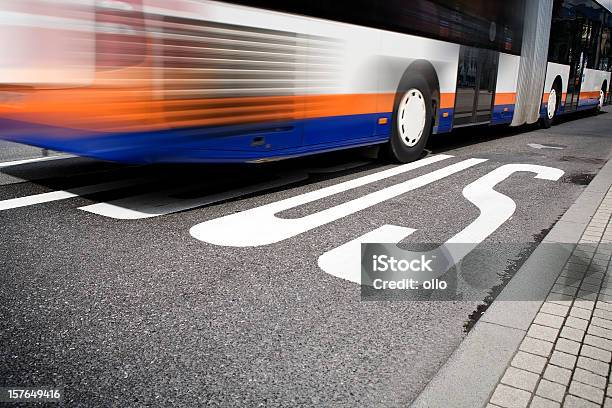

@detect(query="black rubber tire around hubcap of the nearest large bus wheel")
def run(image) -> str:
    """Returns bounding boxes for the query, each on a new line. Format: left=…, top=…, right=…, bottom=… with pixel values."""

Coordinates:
left=381, top=73, right=433, bottom=163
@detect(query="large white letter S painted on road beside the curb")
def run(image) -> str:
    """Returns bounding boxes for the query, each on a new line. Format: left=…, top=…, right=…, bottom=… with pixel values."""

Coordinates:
left=318, top=164, right=564, bottom=283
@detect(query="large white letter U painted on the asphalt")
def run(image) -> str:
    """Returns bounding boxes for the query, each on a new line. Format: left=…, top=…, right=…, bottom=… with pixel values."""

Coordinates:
left=189, top=155, right=487, bottom=247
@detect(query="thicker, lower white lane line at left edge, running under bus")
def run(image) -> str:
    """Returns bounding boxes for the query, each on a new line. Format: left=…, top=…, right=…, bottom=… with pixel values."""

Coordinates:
left=0, top=179, right=142, bottom=211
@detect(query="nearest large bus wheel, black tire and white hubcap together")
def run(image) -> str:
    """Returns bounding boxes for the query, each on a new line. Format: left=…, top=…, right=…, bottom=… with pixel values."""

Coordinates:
left=384, top=76, right=433, bottom=163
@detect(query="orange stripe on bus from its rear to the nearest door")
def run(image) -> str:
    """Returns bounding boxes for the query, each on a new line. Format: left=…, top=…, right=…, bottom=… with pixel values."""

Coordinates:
left=0, top=87, right=464, bottom=132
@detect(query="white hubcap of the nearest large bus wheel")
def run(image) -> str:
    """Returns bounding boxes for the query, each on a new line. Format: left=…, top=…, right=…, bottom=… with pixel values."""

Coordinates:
left=397, top=89, right=427, bottom=147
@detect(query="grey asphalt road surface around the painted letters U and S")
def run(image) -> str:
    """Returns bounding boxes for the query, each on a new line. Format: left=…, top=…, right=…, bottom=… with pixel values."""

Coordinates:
left=0, top=109, right=612, bottom=407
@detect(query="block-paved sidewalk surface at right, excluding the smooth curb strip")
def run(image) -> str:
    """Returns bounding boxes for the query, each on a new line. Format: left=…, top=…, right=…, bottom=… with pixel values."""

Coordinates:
left=487, top=189, right=612, bottom=408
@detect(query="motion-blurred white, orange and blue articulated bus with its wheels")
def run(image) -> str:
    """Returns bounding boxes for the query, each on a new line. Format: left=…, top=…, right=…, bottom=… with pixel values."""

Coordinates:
left=0, top=0, right=612, bottom=163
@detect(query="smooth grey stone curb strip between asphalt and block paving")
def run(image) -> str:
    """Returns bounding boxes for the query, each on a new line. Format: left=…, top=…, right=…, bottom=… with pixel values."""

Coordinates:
left=410, top=152, right=612, bottom=408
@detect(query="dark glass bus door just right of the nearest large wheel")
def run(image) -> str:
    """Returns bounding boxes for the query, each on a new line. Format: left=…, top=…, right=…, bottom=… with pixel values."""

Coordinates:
left=453, top=46, right=499, bottom=127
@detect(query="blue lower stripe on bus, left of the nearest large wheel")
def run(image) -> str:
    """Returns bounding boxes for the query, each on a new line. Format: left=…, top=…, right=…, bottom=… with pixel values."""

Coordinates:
left=0, top=114, right=391, bottom=163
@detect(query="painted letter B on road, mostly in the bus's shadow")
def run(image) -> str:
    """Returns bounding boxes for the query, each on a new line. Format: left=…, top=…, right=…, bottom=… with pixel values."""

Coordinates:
left=79, top=172, right=308, bottom=220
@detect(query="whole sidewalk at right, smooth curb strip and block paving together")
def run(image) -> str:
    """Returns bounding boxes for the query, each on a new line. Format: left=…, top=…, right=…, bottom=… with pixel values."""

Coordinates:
left=412, top=155, right=612, bottom=408
